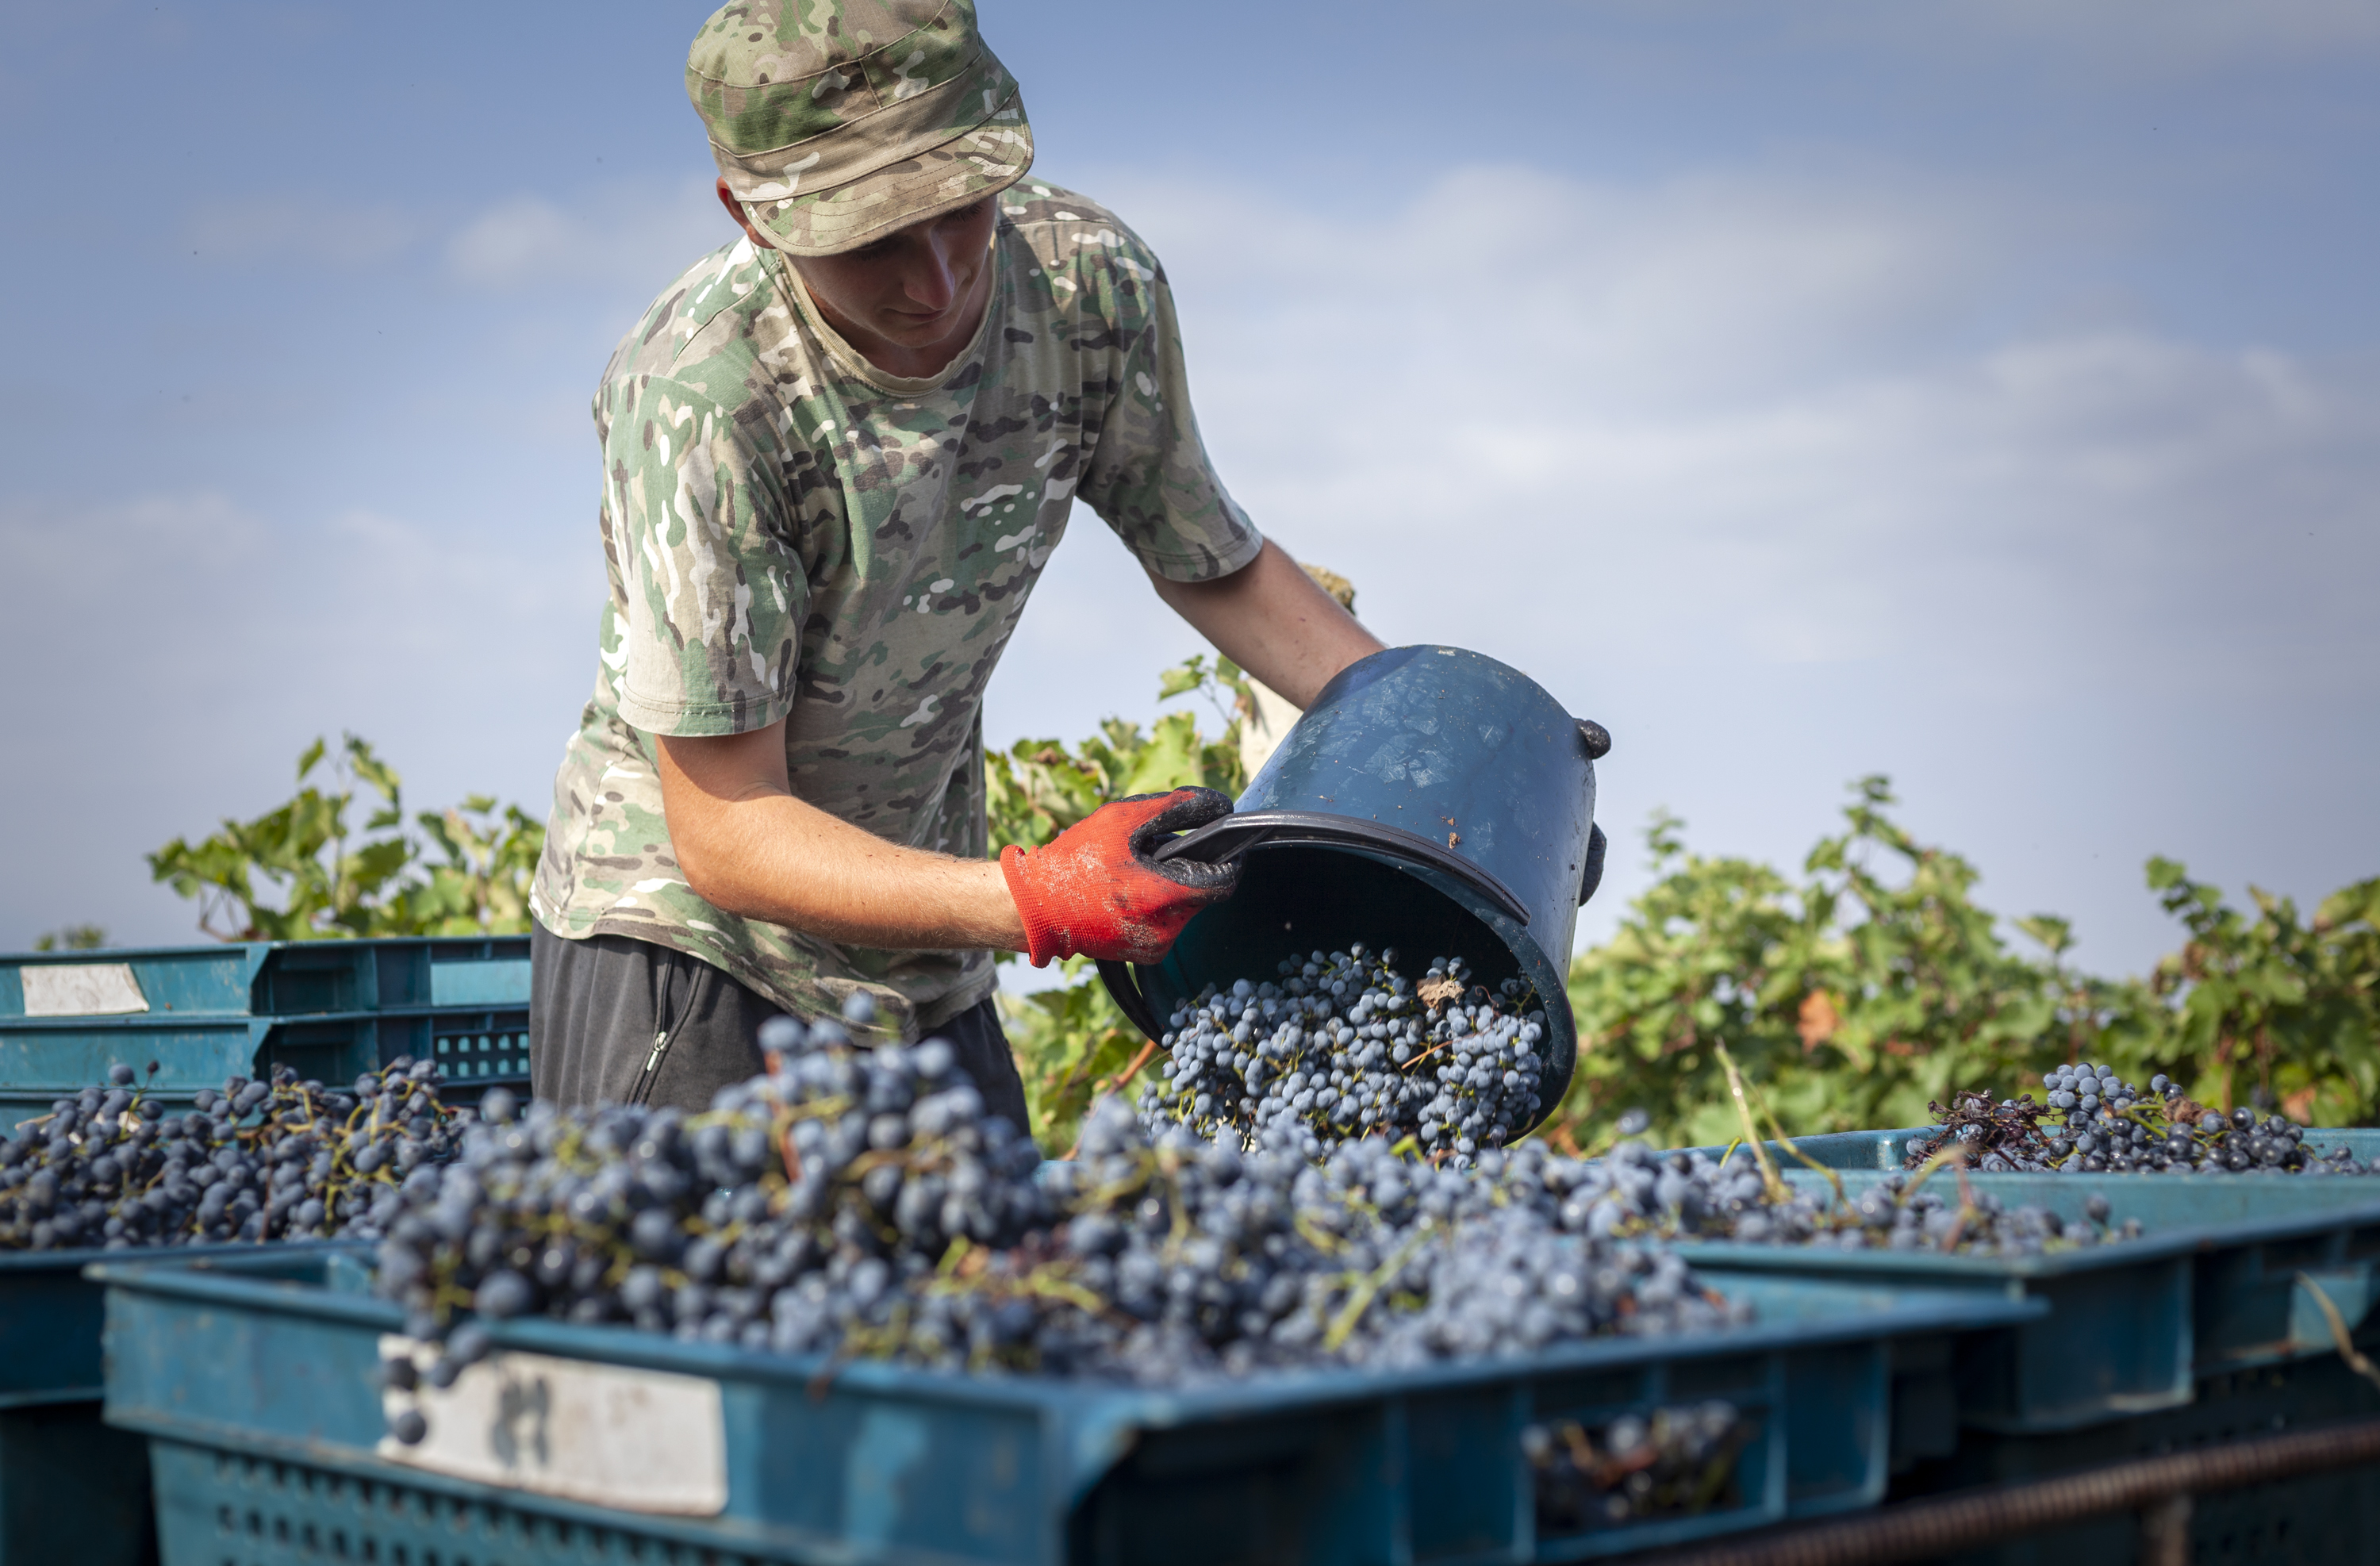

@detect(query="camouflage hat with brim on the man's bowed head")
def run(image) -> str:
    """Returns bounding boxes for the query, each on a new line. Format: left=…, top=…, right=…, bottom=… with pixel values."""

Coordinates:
left=685, top=0, right=1033, bottom=255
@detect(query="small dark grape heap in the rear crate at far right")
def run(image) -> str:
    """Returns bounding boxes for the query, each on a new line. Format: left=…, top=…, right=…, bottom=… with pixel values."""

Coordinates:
left=1906, top=1066, right=2375, bottom=1176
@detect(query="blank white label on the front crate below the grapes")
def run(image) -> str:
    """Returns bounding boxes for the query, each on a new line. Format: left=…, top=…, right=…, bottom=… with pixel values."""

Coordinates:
left=378, top=1335, right=728, bottom=1516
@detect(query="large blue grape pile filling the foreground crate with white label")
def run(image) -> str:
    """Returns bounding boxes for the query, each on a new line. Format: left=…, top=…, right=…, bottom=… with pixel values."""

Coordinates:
left=378, top=1000, right=1740, bottom=1437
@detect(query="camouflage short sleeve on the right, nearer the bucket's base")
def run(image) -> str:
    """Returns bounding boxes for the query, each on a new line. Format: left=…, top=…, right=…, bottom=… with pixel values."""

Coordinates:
left=1078, top=236, right=1264, bottom=581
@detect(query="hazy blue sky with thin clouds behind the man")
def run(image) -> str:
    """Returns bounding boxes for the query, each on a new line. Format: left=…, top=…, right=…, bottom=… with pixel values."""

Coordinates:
left=0, top=0, right=2380, bottom=971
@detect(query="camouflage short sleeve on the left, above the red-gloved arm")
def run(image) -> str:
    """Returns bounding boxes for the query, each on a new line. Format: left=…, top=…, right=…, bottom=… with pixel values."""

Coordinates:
left=605, top=376, right=809, bottom=735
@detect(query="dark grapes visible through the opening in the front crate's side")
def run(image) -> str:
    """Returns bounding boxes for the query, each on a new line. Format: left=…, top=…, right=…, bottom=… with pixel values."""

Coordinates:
left=1521, top=1399, right=1754, bottom=1537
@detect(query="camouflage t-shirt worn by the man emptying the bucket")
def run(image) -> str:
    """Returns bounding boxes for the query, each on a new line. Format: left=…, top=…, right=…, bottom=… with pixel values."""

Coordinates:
left=531, top=181, right=1264, bottom=1038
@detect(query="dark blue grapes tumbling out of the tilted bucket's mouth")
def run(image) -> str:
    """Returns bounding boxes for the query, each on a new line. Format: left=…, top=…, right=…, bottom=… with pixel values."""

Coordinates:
left=1142, top=942, right=1547, bottom=1164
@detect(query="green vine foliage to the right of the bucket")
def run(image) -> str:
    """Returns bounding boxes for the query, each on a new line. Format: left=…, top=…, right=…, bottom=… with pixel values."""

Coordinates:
left=1547, top=778, right=2380, bottom=1145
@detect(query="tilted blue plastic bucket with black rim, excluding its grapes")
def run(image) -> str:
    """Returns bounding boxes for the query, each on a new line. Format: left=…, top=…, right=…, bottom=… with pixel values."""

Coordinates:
left=1100, top=647, right=1611, bottom=1119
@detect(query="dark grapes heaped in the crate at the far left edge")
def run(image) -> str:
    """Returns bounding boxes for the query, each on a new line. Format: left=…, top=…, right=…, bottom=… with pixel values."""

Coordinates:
left=0, top=1059, right=455, bottom=1249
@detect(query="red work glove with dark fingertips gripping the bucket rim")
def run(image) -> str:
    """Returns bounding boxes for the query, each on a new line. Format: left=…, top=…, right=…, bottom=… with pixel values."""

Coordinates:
left=1000, top=788, right=1240, bottom=969
